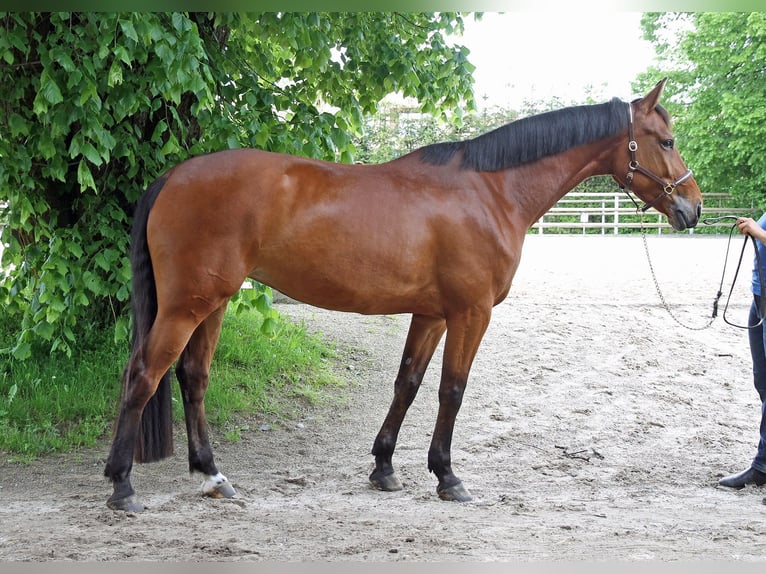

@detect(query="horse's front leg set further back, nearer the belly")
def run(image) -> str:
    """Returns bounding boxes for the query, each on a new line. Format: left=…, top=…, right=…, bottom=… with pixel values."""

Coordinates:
left=370, top=315, right=447, bottom=491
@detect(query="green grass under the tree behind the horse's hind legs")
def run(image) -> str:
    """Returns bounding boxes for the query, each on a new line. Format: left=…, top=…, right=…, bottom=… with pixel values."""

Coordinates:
left=0, top=311, right=340, bottom=462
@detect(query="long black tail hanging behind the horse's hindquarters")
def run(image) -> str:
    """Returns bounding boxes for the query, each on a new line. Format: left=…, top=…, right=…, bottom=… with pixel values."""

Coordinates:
left=124, top=177, right=173, bottom=462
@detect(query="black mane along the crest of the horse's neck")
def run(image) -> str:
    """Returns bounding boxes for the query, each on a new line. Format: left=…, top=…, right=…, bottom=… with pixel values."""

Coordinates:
left=419, top=98, right=628, bottom=171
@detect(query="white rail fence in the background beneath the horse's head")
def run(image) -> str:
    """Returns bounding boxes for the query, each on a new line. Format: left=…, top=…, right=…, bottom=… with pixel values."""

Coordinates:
left=532, top=191, right=760, bottom=235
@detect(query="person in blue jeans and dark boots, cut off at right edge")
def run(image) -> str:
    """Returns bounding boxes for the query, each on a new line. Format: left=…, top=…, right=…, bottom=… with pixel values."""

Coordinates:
left=718, top=213, right=766, bottom=504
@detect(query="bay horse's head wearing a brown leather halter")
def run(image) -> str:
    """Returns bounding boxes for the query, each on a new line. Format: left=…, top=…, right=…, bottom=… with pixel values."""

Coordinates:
left=612, top=78, right=702, bottom=231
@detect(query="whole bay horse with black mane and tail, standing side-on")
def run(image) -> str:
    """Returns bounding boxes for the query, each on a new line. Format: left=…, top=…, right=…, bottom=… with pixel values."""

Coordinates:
left=105, top=80, right=702, bottom=511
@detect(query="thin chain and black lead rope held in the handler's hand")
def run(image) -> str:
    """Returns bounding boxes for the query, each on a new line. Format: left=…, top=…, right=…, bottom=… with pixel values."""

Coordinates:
left=631, top=214, right=766, bottom=331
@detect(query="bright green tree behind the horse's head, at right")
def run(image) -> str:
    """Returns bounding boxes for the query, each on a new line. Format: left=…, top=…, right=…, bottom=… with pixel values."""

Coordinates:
left=639, top=12, right=766, bottom=207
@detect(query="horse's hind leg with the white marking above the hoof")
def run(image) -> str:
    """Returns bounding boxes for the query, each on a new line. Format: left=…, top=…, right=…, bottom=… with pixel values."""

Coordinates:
left=176, top=303, right=236, bottom=498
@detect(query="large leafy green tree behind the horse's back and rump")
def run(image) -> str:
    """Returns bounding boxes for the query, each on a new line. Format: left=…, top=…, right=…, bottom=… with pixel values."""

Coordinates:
left=0, top=12, right=473, bottom=358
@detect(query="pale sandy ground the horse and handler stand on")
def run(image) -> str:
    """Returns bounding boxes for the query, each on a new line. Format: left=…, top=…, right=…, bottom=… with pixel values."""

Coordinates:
left=0, top=236, right=766, bottom=562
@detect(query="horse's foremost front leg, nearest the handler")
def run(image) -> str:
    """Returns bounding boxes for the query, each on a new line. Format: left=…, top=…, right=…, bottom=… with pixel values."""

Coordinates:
left=428, top=308, right=491, bottom=502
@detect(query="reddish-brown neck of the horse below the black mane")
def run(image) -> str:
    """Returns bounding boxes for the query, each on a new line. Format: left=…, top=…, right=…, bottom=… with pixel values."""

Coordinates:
left=494, top=136, right=627, bottom=227
